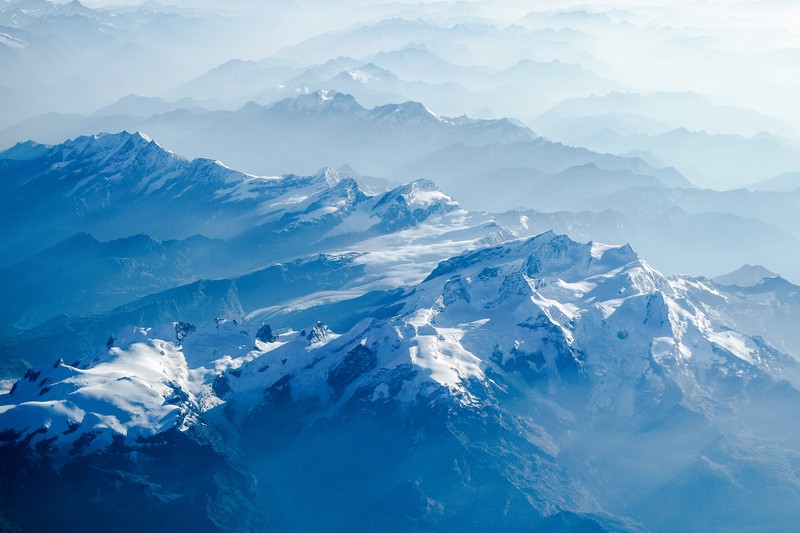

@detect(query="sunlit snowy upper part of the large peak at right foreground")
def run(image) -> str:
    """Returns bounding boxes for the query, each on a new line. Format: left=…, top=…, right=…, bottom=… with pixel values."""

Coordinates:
left=222, top=233, right=795, bottom=414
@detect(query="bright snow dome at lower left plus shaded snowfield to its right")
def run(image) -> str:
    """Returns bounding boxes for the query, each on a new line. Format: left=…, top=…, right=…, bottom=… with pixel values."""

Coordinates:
left=0, top=320, right=260, bottom=456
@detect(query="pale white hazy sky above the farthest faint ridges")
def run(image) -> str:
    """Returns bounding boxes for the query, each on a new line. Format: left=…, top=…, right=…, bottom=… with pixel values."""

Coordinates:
left=14, top=0, right=800, bottom=130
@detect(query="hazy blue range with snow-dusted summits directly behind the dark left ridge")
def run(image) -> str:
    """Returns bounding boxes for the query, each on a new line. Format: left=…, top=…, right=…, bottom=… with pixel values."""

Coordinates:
left=3, top=91, right=692, bottom=210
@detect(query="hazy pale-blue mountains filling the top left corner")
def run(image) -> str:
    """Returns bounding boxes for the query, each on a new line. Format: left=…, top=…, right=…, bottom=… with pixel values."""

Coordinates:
left=0, top=0, right=256, bottom=127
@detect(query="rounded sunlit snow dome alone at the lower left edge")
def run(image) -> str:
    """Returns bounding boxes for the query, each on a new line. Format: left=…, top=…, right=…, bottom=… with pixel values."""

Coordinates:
left=2, top=328, right=198, bottom=455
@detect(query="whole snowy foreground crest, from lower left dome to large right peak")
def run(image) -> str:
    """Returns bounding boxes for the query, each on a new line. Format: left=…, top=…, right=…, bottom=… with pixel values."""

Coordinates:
left=2, top=232, right=798, bottom=446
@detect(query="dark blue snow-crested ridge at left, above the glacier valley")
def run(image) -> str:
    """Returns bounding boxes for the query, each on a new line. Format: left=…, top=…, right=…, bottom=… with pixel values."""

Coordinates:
left=0, top=132, right=468, bottom=264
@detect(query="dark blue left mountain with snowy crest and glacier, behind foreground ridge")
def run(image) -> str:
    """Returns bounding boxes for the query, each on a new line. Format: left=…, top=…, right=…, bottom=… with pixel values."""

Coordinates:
left=0, top=133, right=506, bottom=362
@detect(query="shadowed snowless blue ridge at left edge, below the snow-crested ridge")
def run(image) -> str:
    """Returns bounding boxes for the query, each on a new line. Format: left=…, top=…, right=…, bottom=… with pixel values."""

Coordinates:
left=0, top=233, right=222, bottom=334
